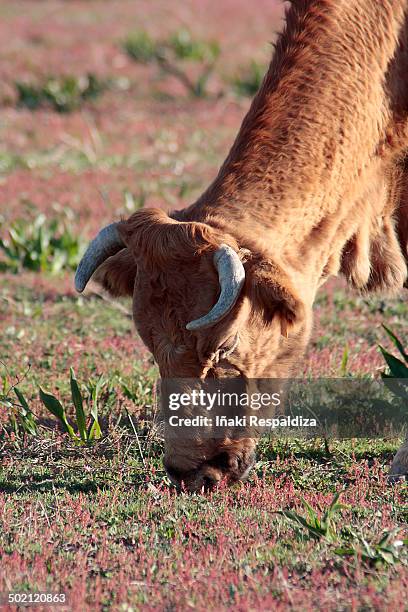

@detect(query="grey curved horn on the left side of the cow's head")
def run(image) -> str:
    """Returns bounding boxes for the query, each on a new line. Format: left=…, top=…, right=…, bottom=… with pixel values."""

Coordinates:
left=75, top=223, right=126, bottom=293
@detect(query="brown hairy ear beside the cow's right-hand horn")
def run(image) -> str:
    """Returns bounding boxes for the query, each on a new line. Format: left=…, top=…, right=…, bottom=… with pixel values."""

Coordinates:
left=247, top=260, right=305, bottom=338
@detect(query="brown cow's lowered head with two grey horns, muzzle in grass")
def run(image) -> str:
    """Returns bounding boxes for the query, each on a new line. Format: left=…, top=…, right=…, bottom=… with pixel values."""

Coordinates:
left=75, top=209, right=310, bottom=490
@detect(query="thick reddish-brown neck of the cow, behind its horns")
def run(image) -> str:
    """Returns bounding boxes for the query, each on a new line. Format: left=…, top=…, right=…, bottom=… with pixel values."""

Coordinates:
left=185, top=0, right=406, bottom=296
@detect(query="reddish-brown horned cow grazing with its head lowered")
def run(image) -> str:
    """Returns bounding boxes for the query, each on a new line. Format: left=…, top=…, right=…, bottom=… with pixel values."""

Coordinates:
left=76, top=0, right=408, bottom=490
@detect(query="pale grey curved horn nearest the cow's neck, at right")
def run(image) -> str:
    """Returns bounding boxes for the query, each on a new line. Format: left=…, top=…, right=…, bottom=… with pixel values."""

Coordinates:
left=186, top=244, right=245, bottom=331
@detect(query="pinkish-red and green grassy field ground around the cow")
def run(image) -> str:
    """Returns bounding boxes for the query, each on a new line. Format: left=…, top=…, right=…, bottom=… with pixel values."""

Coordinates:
left=0, top=0, right=408, bottom=611
